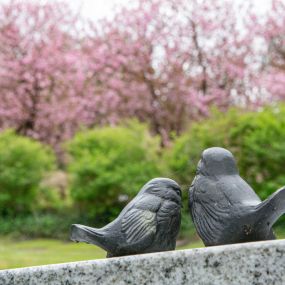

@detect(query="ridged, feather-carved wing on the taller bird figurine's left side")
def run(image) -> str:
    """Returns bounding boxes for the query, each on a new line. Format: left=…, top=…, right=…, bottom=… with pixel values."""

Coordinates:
left=189, top=175, right=229, bottom=245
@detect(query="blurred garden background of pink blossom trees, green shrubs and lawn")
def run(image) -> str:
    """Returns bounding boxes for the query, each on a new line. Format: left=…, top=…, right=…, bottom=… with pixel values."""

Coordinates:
left=0, top=0, right=285, bottom=269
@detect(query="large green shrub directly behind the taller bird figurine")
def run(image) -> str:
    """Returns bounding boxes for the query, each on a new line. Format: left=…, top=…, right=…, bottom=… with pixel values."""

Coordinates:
left=168, top=105, right=285, bottom=231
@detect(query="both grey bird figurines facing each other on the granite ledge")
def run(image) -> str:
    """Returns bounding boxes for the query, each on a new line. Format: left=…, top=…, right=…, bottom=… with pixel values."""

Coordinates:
left=70, top=147, right=285, bottom=257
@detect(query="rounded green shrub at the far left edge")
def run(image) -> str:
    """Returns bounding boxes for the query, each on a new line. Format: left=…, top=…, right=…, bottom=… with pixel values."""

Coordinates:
left=0, top=130, right=55, bottom=215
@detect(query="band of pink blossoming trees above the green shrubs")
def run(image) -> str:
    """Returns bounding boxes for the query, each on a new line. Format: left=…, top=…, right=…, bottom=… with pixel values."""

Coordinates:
left=0, top=0, right=278, bottom=149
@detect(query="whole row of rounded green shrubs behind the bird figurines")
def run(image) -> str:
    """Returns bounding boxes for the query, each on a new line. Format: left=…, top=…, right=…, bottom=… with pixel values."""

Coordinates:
left=0, top=105, right=285, bottom=236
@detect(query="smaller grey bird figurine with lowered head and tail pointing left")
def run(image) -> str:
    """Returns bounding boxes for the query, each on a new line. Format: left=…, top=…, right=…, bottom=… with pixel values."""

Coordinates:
left=70, top=178, right=181, bottom=257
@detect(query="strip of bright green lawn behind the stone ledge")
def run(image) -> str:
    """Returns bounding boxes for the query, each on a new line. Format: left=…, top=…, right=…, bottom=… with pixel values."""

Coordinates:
left=0, top=238, right=203, bottom=269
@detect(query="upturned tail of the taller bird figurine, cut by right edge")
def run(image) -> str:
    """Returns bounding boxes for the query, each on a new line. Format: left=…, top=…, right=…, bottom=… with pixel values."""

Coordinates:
left=256, top=186, right=285, bottom=227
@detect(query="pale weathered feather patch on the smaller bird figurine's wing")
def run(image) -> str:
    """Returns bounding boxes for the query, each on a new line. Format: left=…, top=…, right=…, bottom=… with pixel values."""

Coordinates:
left=122, top=205, right=157, bottom=244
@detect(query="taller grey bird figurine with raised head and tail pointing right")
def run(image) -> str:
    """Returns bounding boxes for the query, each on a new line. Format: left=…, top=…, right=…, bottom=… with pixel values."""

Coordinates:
left=189, top=147, right=285, bottom=246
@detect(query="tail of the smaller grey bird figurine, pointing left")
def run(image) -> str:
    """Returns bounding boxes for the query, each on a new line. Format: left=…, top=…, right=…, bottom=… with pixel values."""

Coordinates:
left=70, top=224, right=108, bottom=251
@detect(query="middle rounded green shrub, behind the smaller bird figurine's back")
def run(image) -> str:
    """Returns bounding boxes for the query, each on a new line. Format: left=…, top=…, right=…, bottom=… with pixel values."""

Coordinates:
left=67, top=121, right=164, bottom=220
